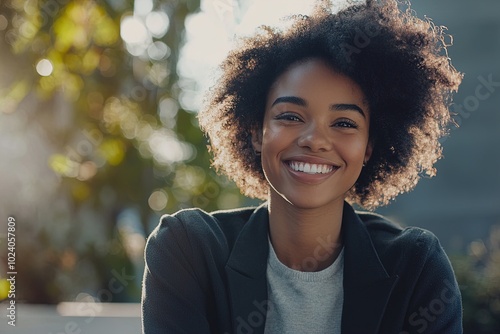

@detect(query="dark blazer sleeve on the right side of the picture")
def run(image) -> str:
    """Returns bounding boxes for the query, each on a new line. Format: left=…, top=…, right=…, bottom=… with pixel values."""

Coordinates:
left=399, top=231, right=463, bottom=334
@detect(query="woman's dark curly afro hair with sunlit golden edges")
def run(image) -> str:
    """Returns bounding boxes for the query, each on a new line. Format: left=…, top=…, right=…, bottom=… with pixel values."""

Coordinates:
left=198, top=0, right=462, bottom=210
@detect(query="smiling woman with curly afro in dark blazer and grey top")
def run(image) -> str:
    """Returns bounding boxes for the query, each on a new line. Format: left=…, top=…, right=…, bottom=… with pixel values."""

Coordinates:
left=142, top=1, right=462, bottom=334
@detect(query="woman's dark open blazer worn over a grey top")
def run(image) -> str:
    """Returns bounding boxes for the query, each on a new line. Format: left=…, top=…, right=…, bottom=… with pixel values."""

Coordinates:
left=142, top=203, right=462, bottom=334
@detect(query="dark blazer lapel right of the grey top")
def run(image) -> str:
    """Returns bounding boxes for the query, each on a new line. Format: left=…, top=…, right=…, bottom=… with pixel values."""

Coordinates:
left=342, top=203, right=398, bottom=334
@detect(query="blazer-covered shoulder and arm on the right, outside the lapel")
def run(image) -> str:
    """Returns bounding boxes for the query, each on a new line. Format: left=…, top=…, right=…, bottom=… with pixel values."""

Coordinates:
left=358, top=213, right=462, bottom=333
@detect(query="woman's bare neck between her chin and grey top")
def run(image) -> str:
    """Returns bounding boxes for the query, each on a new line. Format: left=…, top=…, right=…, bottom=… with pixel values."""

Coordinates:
left=269, top=195, right=344, bottom=271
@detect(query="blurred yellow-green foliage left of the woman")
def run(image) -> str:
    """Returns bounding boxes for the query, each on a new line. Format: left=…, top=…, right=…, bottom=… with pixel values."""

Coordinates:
left=0, top=0, right=249, bottom=303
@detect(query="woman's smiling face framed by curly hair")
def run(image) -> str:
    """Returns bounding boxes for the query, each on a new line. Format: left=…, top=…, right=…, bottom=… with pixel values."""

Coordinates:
left=253, top=59, right=372, bottom=209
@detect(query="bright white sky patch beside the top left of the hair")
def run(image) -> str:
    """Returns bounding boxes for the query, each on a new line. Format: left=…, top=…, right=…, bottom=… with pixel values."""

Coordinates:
left=178, top=0, right=363, bottom=111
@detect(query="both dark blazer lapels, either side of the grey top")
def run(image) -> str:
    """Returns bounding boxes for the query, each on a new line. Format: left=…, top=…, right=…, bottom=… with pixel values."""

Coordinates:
left=226, top=203, right=397, bottom=334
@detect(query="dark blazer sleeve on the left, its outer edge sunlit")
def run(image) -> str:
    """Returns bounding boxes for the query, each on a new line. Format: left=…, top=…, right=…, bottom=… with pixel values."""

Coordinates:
left=141, top=216, right=210, bottom=334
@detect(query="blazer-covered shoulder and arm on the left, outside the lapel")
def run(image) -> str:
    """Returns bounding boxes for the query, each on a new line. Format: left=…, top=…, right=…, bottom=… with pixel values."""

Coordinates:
left=142, top=208, right=260, bottom=333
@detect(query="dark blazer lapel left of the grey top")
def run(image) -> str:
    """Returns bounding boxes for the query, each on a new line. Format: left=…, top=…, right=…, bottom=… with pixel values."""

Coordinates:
left=226, top=204, right=269, bottom=334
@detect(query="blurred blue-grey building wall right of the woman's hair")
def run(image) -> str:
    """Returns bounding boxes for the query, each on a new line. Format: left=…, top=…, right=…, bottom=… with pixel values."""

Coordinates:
left=378, top=0, right=500, bottom=252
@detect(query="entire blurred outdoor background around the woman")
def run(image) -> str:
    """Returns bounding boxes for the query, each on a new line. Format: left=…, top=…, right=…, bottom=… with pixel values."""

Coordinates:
left=0, top=0, right=500, bottom=333
